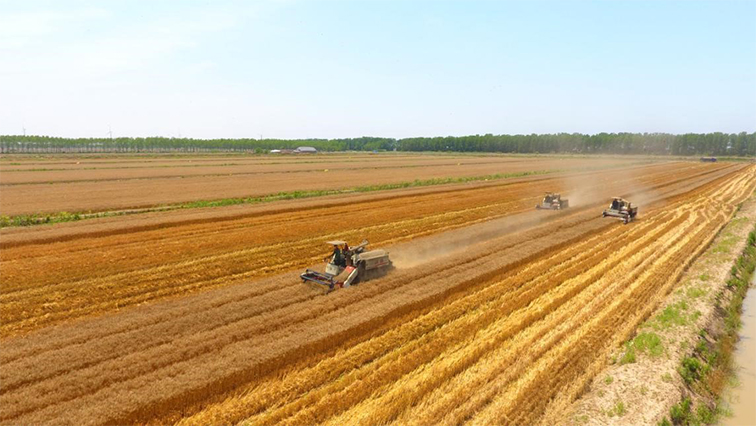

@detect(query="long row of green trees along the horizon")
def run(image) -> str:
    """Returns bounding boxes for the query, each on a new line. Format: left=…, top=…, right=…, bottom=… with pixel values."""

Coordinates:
left=0, top=132, right=756, bottom=156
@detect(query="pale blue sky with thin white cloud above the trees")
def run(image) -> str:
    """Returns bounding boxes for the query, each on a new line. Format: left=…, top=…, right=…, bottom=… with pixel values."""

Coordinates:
left=0, top=0, right=756, bottom=138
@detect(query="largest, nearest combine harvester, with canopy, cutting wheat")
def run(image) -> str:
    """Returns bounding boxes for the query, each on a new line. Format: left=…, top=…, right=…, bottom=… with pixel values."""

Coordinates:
left=300, top=240, right=393, bottom=293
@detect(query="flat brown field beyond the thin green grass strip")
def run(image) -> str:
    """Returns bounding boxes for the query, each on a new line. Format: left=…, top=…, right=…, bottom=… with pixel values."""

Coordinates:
left=0, top=154, right=638, bottom=216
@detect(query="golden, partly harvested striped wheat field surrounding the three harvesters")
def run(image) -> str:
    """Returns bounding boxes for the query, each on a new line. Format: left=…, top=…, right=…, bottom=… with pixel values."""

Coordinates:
left=0, top=154, right=756, bottom=425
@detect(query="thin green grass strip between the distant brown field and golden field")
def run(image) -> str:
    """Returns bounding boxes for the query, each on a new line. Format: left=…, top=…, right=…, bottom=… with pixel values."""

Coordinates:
left=0, top=170, right=552, bottom=228
